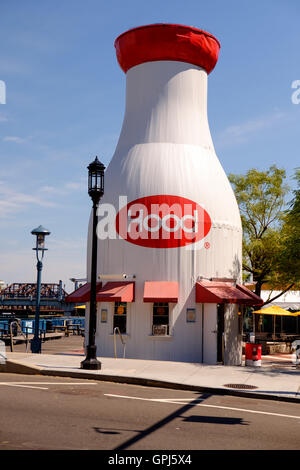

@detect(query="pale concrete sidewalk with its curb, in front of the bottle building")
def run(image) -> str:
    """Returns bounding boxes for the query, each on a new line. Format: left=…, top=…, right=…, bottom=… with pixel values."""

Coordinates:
left=0, top=352, right=300, bottom=402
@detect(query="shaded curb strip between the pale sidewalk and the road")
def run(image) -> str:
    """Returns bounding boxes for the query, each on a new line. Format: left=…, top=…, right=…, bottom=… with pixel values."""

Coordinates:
left=0, top=360, right=300, bottom=403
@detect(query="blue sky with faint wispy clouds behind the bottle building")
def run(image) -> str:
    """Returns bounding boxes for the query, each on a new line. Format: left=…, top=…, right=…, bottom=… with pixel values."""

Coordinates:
left=0, top=0, right=300, bottom=291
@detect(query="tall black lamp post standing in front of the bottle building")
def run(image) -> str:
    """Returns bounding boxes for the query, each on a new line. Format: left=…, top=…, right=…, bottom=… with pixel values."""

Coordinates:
left=81, top=157, right=105, bottom=370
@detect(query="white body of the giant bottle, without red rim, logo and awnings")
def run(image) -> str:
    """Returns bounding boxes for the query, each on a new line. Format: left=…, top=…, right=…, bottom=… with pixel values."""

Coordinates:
left=88, top=61, right=242, bottom=362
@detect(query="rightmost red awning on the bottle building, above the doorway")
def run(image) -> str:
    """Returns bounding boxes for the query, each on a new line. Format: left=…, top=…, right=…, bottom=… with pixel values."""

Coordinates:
left=196, top=280, right=263, bottom=305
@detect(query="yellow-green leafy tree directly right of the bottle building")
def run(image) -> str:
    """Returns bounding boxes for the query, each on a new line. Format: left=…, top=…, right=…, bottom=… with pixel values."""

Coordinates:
left=229, top=165, right=293, bottom=301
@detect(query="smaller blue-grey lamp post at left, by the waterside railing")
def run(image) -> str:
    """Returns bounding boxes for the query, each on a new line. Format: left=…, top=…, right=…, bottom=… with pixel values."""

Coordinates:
left=31, top=225, right=50, bottom=353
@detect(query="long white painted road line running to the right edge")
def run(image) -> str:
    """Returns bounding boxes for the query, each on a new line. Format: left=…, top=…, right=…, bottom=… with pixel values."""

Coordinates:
left=104, top=393, right=300, bottom=420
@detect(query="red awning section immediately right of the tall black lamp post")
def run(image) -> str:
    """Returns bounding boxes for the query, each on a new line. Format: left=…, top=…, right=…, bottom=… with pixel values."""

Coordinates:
left=96, top=281, right=135, bottom=302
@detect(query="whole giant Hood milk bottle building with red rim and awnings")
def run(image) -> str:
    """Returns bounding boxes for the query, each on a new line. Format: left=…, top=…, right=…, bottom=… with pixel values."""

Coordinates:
left=82, top=24, right=260, bottom=365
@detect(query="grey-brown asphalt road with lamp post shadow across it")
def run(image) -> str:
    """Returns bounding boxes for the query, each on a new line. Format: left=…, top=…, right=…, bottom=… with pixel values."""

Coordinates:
left=0, top=373, right=300, bottom=452
